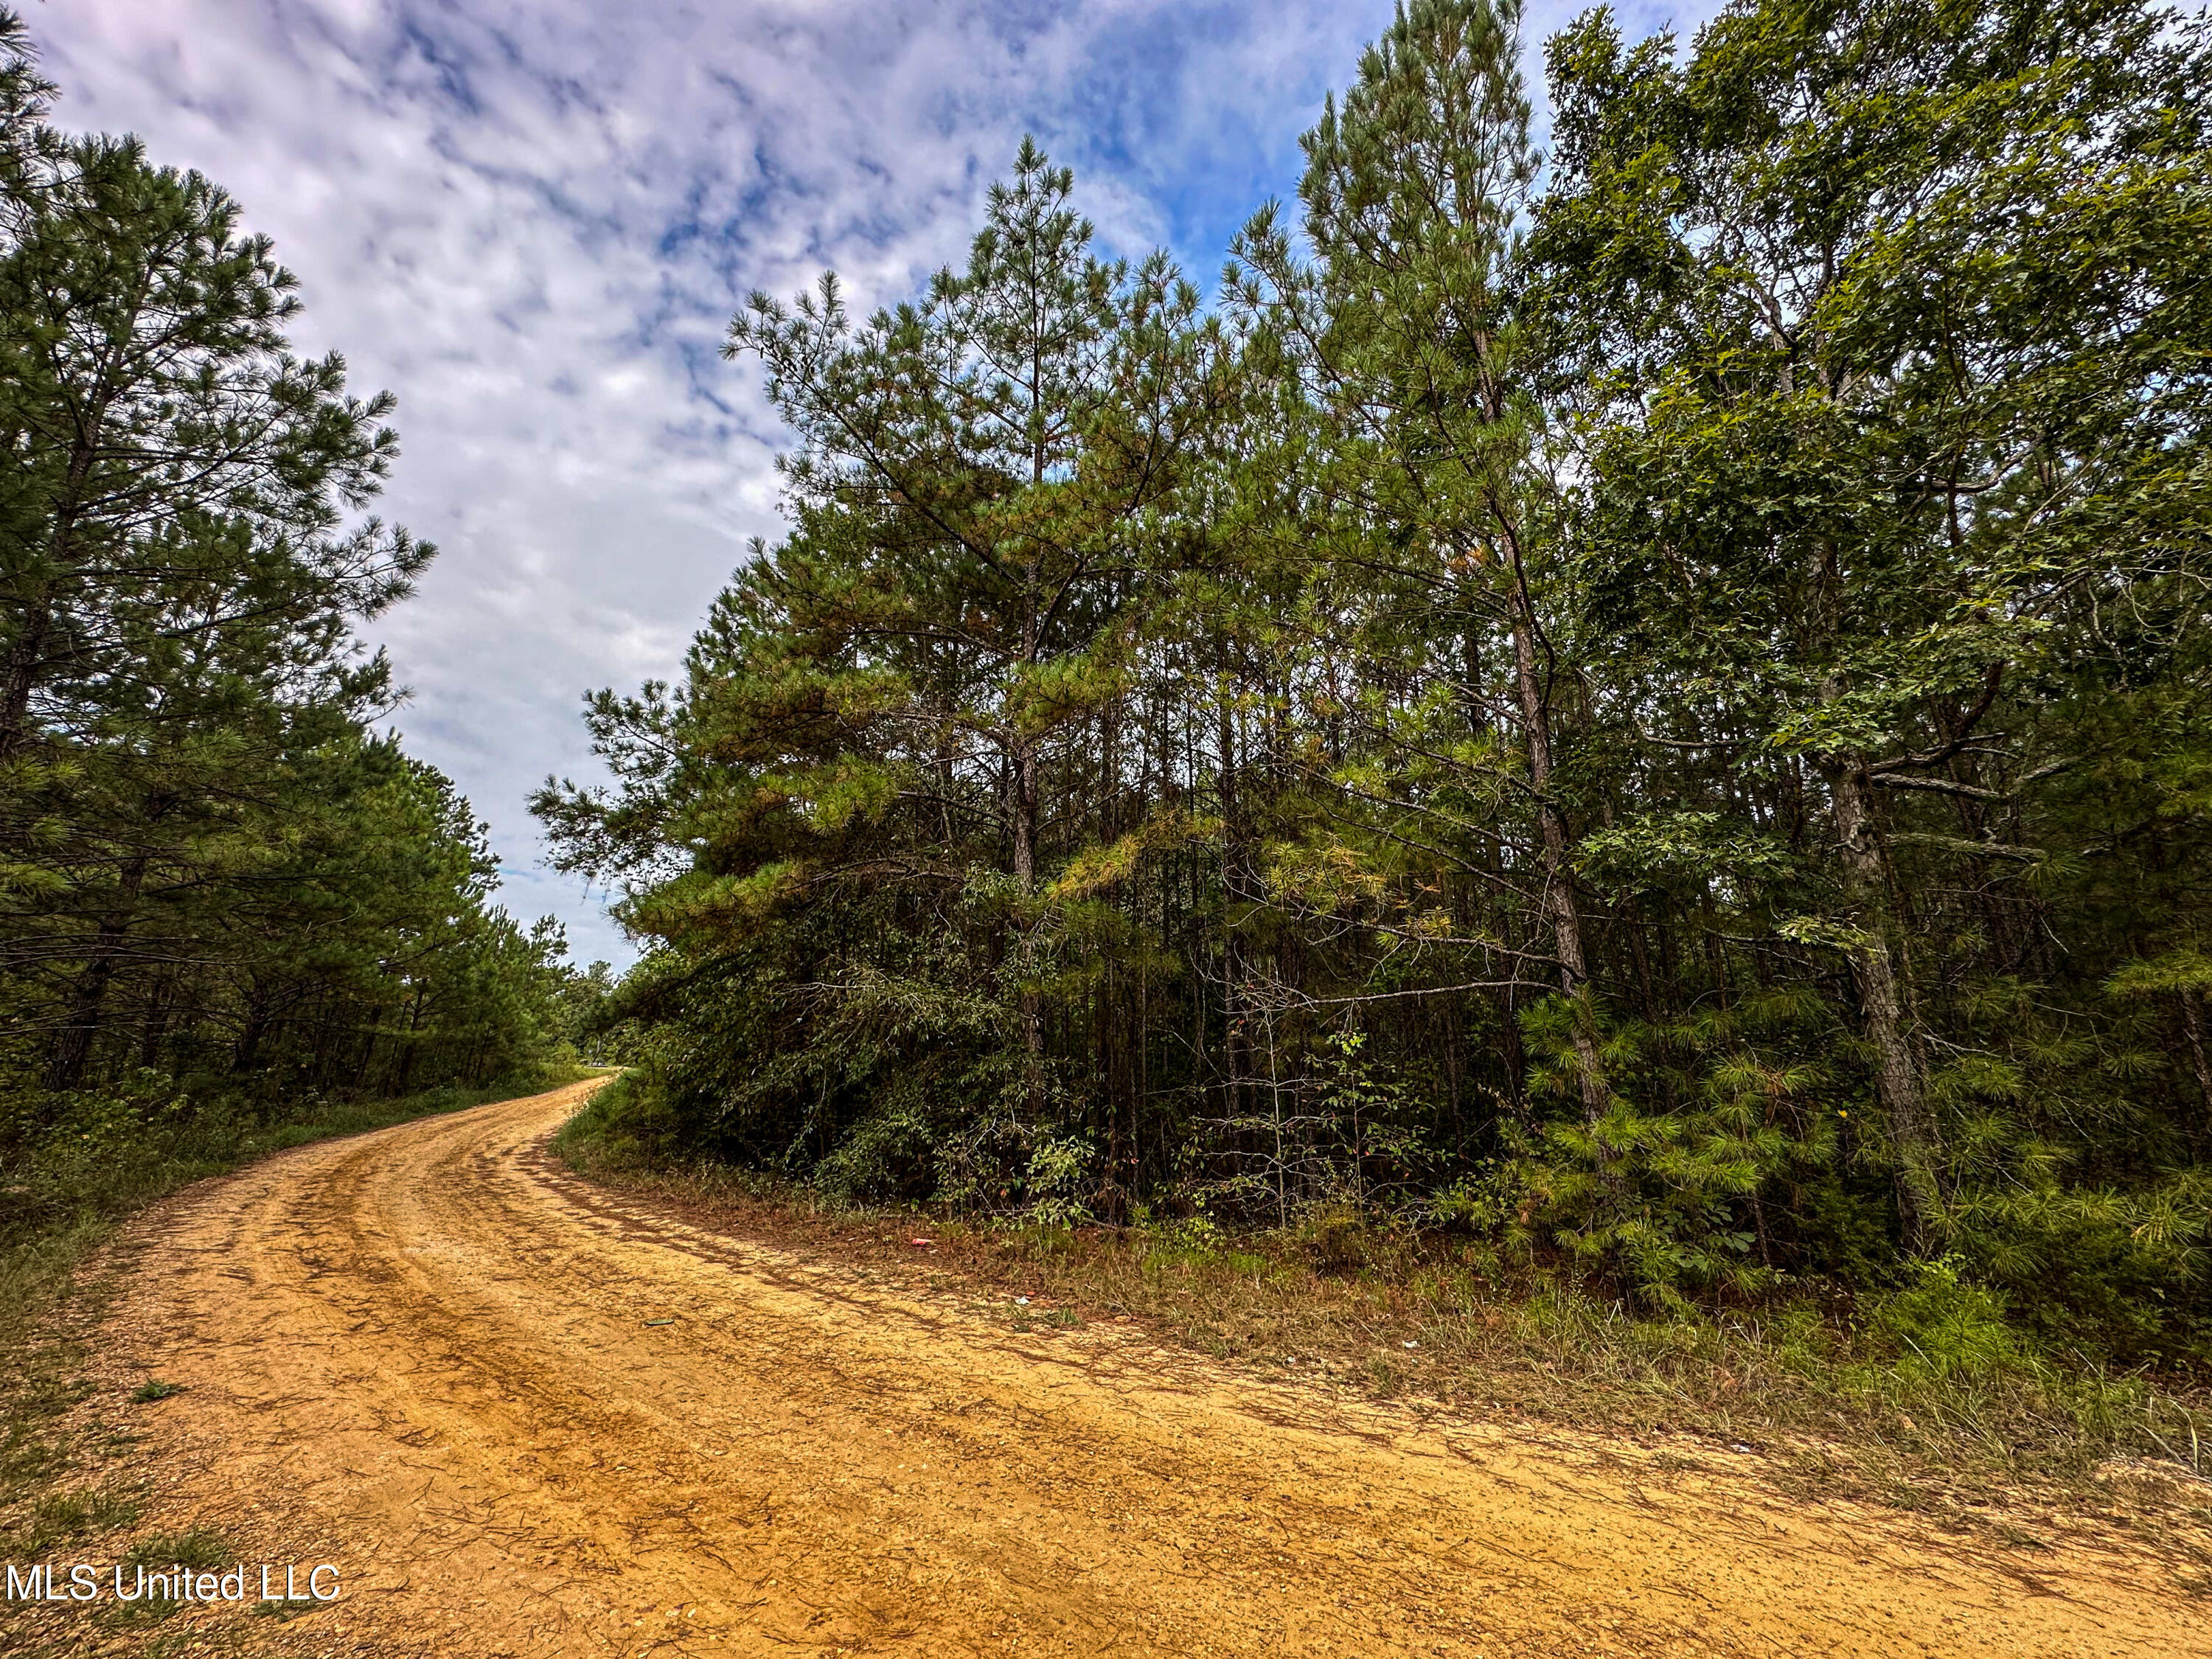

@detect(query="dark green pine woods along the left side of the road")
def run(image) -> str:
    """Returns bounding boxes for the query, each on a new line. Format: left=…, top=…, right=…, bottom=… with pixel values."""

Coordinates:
left=0, top=11, right=591, bottom=1197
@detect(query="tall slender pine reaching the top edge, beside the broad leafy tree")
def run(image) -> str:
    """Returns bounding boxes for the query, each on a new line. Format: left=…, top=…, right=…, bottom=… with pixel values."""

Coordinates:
left=1239, top=0, right=1608, bottom=1135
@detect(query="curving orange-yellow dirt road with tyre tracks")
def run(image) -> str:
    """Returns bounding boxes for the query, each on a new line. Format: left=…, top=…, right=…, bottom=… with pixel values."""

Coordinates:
left=43, top=1086, right=2212, bottom=1659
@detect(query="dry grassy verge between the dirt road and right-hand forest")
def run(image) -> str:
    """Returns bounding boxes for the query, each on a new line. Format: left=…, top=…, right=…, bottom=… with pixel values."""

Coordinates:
left=560, top=1115, right=2212, bottom=1593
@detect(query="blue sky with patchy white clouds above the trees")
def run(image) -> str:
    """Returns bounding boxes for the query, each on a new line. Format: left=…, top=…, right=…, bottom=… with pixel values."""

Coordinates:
left=30, top=0, right=1710, bottom=962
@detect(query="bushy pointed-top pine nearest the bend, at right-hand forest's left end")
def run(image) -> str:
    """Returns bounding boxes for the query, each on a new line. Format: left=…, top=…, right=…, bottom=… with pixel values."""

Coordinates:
left=538, top=144, right=1219, bottom=1194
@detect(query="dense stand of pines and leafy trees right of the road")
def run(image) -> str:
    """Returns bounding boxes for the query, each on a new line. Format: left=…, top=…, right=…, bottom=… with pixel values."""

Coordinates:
left=544, top=0, right=2212, bottom=1358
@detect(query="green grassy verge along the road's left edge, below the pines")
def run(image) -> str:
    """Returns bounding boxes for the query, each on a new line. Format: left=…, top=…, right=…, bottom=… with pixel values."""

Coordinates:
left=0, top=1068, right=597, bottom=1584
